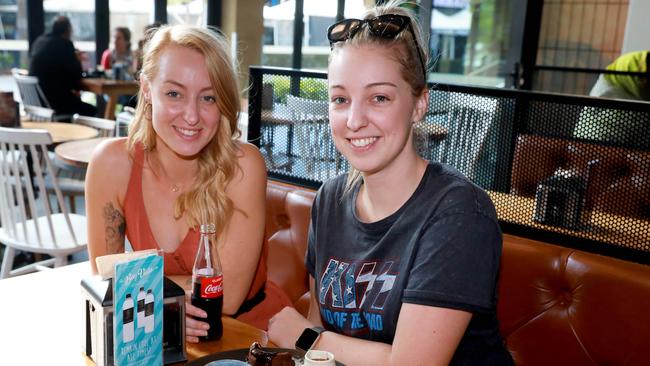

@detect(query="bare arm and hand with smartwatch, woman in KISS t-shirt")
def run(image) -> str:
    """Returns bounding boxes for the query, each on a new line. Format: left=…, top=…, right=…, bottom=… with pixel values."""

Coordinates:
left=269, top=303, right=472, bottom=366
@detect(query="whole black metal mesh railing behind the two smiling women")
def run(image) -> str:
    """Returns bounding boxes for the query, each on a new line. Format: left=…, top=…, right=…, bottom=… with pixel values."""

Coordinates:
left=249, top=68, right=650, bottom=263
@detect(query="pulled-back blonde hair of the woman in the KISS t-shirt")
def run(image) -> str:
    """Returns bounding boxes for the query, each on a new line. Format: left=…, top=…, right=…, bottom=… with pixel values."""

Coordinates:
left=329, top=0, right=429, bottom=194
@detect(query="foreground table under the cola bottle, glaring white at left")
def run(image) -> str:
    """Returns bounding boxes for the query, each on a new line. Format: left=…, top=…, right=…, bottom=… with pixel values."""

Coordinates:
left=0, top=262, right=273, bottom=366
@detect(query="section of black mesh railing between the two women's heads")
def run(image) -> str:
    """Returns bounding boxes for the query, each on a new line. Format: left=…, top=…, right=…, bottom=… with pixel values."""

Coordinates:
left=246, top=71, right=348, bottom=186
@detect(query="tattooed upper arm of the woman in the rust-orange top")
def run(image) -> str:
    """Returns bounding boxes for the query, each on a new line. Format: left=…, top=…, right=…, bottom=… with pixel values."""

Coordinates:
left=85, top=139, right=130, bottom=273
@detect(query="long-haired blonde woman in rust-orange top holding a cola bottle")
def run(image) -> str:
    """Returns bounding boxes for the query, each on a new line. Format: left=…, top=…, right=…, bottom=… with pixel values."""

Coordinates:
left=85, top=25, right=291, bottom=342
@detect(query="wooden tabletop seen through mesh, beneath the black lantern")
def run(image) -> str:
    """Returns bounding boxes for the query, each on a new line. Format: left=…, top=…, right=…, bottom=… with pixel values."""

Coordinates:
left=487, top=191, right=650, bottom=249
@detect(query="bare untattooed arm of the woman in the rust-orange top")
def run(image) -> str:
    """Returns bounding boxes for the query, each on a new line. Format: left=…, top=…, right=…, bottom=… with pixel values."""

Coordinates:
left=218, top=143, right=266, bottom=314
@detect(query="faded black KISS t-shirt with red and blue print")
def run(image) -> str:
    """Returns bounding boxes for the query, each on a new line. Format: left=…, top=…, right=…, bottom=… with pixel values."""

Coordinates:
left=305, top=162, right=512, bottom=365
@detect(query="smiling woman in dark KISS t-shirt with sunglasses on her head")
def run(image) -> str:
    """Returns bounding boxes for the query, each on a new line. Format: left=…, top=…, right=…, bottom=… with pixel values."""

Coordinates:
left=269, top=1, right=513, bottom=365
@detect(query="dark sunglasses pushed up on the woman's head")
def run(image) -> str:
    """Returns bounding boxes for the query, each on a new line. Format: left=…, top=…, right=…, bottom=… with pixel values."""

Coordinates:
left=327, top=14, right=427, bottom=80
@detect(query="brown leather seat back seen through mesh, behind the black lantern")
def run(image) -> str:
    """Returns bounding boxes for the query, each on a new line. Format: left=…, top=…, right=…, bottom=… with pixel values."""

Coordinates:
left=511, top=135, right=650, bottom=219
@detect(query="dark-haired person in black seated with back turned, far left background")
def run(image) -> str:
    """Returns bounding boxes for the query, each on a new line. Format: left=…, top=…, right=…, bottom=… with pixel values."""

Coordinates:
left=29, top=16, right=97, bottom=116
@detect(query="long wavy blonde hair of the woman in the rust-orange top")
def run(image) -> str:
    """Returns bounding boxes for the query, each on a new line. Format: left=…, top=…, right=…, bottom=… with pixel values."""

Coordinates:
left=127, top=25, right=241, bottom=231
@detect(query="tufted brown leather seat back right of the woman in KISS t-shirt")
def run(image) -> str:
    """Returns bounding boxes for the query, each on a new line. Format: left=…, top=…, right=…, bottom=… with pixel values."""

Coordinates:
left=498, top=235, right=650, bottom=365
